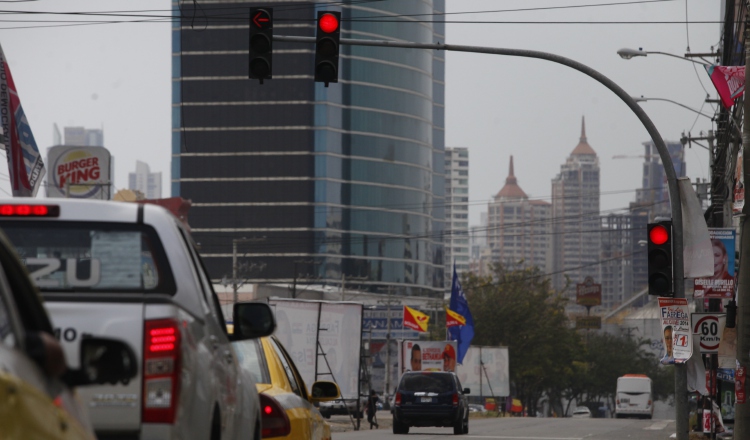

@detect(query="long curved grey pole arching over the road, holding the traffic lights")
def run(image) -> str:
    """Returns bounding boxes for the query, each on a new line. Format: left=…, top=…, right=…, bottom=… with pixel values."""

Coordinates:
left=273, top=35, right=689, bottom=440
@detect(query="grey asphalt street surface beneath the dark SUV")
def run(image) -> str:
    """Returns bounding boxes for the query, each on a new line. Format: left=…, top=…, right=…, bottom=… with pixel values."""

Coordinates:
left=334, top=417, right=675, bottom=440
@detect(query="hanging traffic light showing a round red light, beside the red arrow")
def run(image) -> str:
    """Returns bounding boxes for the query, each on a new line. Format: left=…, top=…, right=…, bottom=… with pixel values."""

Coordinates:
left=315, top=11, right=341, bottom=87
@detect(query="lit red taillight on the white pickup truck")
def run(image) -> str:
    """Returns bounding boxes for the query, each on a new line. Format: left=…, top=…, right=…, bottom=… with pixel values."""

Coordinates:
left=141, top=319, right=180, bottom=423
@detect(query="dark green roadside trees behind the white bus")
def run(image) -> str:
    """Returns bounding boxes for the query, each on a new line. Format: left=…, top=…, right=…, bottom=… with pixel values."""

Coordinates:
left=462, top=265, right=674, bottom=415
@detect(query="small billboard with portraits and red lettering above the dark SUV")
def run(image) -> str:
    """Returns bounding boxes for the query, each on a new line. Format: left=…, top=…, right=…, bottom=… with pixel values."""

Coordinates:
left=398, top=341, right=458, bottom=375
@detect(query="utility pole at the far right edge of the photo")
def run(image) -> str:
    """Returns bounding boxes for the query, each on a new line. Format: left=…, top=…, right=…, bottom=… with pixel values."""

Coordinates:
left=736, top=19, right=750, bottom=439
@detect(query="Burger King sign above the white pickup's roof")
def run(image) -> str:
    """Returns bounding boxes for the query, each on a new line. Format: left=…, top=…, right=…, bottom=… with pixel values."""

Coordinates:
left=47, top=145, right=112, bottom=200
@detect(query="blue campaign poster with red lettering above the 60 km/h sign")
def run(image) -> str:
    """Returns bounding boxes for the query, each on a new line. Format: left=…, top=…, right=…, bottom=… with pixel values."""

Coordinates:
left=693, top=228, right=736, bottom=298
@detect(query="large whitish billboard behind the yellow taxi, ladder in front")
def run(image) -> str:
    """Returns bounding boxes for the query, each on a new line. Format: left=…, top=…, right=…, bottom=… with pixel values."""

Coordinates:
left=268, top=298, right=362, bottom=399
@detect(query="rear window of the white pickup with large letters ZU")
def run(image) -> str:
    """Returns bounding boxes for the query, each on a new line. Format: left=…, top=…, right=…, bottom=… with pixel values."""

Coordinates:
left=0, top=221, right=175, bottom=294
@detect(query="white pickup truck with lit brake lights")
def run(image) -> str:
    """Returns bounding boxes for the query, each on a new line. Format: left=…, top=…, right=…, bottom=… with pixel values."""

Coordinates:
left=0, top=199, right=275, bottom=440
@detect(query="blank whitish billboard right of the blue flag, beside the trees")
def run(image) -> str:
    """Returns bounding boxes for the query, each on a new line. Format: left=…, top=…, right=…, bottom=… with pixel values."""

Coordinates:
left=456, top=346, right=510, bottom=397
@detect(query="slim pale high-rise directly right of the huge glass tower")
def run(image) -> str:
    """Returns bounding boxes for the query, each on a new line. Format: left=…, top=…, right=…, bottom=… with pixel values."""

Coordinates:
left=444, top=147, right=470, bottom=291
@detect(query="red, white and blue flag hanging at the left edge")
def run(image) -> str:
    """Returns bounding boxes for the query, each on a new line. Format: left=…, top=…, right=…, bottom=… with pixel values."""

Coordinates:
left=0, top=46, right=44, bottom=197
